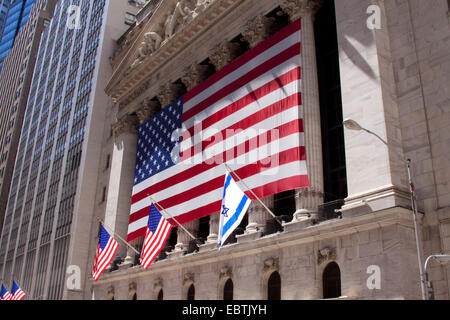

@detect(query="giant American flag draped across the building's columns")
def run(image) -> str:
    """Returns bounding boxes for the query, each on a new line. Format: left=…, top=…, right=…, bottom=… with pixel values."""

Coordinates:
left=127, top=20, right=309, bottom=241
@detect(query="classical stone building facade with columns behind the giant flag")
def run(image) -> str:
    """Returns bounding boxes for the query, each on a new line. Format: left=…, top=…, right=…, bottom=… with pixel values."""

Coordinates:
left=66, top=0, right=450, bottom=300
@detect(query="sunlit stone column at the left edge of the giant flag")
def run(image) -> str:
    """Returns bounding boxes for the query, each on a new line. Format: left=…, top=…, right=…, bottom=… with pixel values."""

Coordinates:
left=104, top=115, right=138, bottom=261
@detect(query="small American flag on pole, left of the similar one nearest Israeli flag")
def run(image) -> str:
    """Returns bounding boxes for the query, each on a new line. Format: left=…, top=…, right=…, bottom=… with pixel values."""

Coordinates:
left=92, top=226, right=119, bottom=281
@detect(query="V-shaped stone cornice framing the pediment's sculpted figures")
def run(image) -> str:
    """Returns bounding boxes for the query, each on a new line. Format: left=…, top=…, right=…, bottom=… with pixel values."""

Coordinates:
left=105, top=0, right=241, bottom=105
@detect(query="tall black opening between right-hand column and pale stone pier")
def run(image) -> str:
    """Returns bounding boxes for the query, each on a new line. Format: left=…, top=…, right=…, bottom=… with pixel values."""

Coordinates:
left=314, top=1, right=347, bottom=210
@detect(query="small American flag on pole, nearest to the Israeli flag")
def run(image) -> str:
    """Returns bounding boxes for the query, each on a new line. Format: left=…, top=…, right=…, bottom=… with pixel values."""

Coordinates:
left=141, top=204, right=172, bottom=269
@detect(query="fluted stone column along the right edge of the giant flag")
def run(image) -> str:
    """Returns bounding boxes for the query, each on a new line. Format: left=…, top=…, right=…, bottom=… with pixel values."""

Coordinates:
left=280, top=0, right=323, bottom=230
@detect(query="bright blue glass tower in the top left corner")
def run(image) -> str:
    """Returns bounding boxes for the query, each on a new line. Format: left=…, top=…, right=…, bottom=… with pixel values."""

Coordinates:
left=0, top=0, right=36, bottom=70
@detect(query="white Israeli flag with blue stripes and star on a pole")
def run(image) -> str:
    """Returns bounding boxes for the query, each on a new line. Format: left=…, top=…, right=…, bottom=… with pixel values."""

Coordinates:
left=218, top=171, right=251, bottom=248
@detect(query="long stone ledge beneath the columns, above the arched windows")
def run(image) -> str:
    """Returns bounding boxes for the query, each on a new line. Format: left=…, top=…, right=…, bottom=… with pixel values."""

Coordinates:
left=90, top=207, right=414, bottom=286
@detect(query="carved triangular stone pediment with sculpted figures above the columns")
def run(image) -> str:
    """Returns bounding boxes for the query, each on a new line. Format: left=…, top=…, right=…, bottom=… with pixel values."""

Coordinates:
left=105, top=0, right=240, bottom=107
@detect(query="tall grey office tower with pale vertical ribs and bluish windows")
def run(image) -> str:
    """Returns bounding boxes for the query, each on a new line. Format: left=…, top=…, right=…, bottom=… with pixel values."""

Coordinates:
left=0, top=0, right=139, bottom=300
